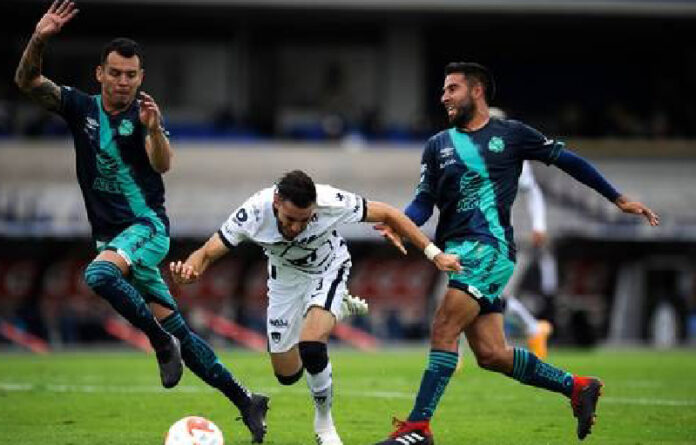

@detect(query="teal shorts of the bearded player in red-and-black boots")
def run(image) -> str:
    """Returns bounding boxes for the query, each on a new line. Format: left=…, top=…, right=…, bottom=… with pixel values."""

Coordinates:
left=445, top=241, right=515, bottom=314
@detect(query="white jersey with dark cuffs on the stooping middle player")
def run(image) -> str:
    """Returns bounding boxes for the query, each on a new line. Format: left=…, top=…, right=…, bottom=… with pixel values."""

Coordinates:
left=218, top=184, right=367, bottom=275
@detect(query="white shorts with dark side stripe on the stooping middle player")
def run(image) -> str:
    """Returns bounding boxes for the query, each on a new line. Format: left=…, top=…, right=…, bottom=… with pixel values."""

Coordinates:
left=266, top=260, right=351, bottom=353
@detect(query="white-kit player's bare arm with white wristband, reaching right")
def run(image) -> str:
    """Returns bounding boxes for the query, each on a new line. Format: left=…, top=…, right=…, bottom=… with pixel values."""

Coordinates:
left=366, top=201, right=462, bottom=271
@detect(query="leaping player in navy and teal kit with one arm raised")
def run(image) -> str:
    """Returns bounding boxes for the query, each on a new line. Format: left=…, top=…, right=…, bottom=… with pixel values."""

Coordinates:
left=15, top=1, right=268, bottom=443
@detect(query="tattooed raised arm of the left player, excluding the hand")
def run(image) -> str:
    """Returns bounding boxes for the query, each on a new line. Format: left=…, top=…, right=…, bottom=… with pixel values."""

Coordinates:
left=15, top=34, right=61, bottom=111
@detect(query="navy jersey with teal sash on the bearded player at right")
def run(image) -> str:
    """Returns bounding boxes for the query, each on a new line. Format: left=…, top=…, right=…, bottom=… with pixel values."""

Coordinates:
left=416, top=118, right=563, bottom=260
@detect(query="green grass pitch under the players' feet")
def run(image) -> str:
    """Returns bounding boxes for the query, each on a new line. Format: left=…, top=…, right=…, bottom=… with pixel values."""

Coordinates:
left=0, top=347, right=696, bottom=445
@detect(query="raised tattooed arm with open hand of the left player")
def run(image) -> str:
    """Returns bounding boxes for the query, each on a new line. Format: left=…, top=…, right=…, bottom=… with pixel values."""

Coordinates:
left=15, top=0, right=79, bottom=111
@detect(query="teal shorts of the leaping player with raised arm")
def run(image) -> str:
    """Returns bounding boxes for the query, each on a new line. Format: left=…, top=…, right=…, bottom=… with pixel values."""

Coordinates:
left=97, top=220, right=177, bottom=310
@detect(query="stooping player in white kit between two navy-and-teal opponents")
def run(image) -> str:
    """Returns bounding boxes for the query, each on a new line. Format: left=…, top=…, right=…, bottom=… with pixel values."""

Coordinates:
left=170, top=170, right=461, bottom=445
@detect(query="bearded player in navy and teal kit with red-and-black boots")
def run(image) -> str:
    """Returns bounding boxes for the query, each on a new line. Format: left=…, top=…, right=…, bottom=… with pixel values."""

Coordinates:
left=372, top=62, right=659, bottom=445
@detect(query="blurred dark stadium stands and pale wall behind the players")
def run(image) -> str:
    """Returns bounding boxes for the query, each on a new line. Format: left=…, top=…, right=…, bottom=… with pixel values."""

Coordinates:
left=0, top=0, right=696, bottom=351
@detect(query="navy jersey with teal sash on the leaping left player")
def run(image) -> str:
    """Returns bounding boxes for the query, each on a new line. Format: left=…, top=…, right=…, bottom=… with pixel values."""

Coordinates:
left=59, top=87, right=169, bottom=240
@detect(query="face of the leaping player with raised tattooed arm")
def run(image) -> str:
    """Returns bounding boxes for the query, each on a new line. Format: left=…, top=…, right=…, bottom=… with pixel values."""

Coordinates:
left=97, top=51, right=143, bottom=110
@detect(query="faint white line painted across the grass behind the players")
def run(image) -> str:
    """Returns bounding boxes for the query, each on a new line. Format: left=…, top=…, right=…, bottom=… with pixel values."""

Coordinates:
left=0, top=382, right=696, bottom=406
